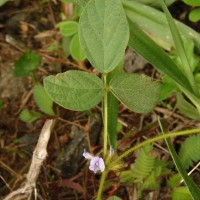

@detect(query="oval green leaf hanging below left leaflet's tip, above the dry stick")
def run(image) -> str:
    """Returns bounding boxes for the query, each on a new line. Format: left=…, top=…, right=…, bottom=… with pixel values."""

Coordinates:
left=33, top=84, right=55, bottom=115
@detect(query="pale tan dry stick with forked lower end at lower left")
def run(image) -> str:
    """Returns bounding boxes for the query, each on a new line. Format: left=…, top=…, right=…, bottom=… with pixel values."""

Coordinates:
left=4, top=120, right=53, bottom=200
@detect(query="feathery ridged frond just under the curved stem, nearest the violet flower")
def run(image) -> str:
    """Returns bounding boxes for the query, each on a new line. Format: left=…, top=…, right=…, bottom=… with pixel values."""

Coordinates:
left=131, top=145, right=155, bottom=182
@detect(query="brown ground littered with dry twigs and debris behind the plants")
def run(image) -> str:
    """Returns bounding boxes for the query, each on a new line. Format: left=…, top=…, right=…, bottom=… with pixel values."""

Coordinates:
left=0, top=0, right=200, bottom=200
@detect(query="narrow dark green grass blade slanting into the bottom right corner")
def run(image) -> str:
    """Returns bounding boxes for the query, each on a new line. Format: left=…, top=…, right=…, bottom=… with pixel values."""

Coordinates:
left=165, top=139, right=200, bottom=200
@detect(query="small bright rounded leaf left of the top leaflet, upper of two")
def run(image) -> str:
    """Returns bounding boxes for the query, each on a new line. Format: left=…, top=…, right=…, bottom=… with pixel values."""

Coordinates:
left=60, top=21, right=78, bottom=37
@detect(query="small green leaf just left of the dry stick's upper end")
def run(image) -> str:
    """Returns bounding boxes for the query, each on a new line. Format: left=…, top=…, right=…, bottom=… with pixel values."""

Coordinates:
left=19, top=109, right=42, bottom=123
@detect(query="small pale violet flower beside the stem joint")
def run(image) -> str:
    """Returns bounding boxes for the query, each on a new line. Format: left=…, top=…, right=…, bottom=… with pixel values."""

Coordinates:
left=83, top=149, right=105, bottom=174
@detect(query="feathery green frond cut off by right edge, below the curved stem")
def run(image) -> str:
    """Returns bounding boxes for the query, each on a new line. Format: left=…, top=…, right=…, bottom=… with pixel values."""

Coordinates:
left=179, top=134, right=200, bottom=169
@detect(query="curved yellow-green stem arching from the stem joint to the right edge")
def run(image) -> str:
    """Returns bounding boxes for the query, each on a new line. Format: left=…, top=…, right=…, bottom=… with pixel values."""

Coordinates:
left=112, top=129, right=200, bottom=165
